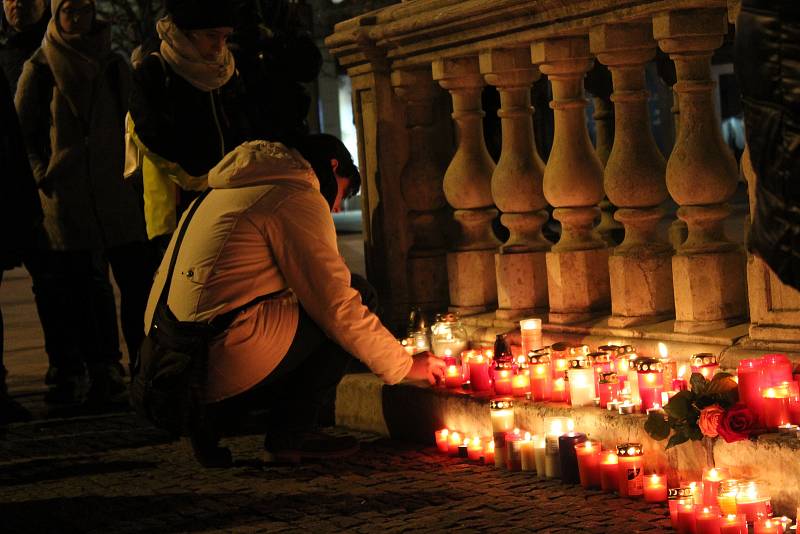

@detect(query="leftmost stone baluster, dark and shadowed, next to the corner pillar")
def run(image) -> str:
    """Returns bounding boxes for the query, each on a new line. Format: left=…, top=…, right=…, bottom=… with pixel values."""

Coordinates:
left=392, top=69, right=448, bottom=311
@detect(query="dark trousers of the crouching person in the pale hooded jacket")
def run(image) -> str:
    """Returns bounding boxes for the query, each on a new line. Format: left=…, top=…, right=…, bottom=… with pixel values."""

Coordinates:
left=209, top=307, right=351, bottom=448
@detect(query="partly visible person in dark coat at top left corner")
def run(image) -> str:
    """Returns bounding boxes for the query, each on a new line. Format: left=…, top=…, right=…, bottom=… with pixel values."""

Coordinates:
left=0, top=0, right=50, bottom=90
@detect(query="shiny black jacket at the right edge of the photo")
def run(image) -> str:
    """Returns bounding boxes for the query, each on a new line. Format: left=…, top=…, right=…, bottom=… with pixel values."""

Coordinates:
left=736, top=0, right=800, bottom=289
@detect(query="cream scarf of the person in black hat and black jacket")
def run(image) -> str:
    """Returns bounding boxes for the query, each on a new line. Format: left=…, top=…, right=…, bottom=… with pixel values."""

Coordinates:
left=156, top=16, right=235, bottom=92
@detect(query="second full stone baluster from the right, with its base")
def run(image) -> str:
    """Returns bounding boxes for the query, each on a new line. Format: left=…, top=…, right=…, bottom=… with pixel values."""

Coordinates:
left=590, top=24, right=675, bottom=327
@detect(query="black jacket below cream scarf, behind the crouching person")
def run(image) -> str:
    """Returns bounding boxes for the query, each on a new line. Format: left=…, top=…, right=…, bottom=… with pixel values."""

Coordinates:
left=130, top=54, right=250, bottom=176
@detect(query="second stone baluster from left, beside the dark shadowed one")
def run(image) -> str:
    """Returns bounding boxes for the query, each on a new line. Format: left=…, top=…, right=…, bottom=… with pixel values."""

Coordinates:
left=433, top=56, right=499, bottom=314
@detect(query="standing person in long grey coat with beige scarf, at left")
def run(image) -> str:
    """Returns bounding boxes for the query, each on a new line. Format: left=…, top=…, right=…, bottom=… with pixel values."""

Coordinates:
left=16, top=0, right=150, bottom=408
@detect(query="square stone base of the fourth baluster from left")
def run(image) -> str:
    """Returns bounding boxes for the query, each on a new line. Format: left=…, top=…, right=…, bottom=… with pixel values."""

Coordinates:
left=547, top=248, right=611, bottom=324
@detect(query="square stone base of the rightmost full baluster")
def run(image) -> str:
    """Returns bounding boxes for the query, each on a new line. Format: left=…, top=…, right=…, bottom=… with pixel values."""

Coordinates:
left=672, top=249, right=747, bottom=333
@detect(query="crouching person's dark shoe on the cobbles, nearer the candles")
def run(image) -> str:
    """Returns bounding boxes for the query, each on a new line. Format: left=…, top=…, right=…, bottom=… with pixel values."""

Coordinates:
left=264, top=431, right=359, bottom=464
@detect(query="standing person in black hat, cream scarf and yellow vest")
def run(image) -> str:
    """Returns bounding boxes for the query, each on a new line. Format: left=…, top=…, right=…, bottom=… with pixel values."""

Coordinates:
left=130, top=0, right=250, bottom=254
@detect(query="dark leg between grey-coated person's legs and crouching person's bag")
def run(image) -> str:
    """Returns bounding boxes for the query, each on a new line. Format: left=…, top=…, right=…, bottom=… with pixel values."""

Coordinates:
left=106, top=242, right=155, bottom=360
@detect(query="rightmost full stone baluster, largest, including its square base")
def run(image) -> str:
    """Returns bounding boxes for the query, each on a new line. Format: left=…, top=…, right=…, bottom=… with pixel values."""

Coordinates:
left=653, top=9, right=747, bottom=332
